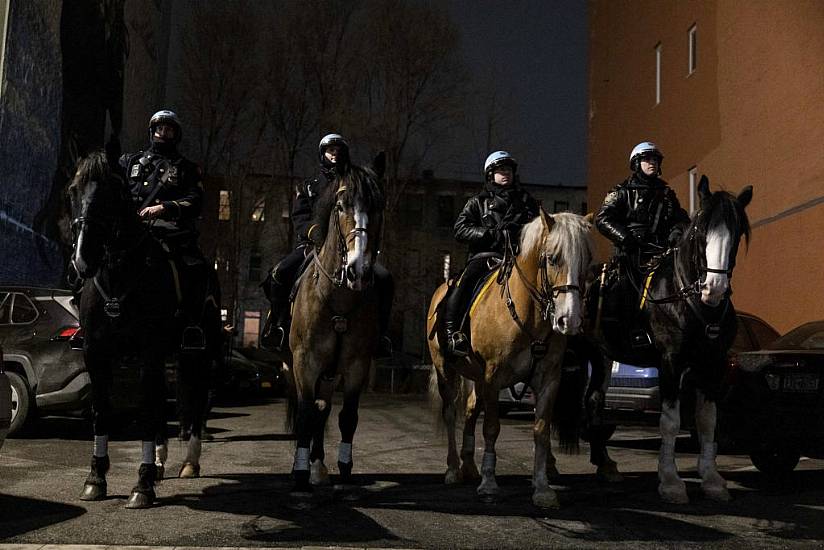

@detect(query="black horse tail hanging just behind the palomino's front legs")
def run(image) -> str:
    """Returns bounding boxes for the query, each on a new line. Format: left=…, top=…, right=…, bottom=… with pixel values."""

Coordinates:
left=552, top=363, right=587, bottom=454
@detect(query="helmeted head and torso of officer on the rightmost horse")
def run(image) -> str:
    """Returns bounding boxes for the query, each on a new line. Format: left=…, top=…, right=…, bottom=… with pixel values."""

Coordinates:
left=595, top=141, right=689, bottom=267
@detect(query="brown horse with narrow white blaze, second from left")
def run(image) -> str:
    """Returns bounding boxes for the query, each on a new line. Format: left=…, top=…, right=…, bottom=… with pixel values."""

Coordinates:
left=287, top=155, right=385, bottom=494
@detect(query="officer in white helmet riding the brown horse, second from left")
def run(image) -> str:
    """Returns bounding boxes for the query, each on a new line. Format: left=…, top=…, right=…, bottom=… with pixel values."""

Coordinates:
left=262, top=134, right=394, bottom=357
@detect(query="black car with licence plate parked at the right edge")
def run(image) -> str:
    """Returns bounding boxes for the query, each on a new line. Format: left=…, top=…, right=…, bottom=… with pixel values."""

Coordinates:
left=718, top=320, right=824, bottom=474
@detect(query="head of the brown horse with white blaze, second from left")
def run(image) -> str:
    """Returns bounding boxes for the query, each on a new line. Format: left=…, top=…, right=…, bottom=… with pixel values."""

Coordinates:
left=321, top=154, right=385, bottom=291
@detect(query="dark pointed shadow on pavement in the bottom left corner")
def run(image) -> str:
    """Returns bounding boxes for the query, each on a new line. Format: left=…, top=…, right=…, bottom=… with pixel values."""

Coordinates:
left=0, top=494, right=86, bottom=540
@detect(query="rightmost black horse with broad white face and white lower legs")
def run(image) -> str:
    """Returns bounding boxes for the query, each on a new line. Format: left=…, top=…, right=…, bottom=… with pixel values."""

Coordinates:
left=595, top=176, right=752, bottom=503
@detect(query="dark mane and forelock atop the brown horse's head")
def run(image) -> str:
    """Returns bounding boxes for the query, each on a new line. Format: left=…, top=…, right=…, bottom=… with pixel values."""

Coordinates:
left=312, top=165, right=386, bottom=244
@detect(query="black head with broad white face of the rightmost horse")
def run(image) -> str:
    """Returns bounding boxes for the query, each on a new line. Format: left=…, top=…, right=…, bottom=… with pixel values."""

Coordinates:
left=686, top=176, right=752, bottom=306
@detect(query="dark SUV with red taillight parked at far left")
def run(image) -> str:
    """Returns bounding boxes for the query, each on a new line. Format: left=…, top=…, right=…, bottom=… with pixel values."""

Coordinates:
left=0, top=286, right=91, bottom=434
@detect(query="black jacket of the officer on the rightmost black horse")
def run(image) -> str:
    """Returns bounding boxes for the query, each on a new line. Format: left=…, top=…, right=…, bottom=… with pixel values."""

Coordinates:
left=595, top=174, right=690, bottom=252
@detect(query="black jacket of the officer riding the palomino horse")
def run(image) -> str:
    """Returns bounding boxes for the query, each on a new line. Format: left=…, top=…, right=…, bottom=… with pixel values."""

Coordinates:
left=454, top=184, right=540, bottom=261
